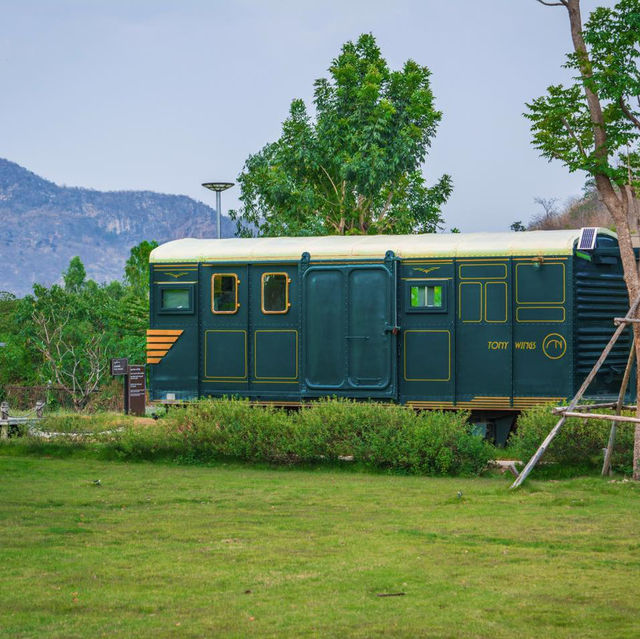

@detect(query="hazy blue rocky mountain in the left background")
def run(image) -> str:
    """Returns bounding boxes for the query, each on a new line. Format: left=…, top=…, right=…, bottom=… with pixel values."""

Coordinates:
left=0, top=158, right=235, bottom=295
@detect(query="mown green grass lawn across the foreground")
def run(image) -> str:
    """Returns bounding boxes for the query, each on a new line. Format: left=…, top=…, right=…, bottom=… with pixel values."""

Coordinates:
left=0, top=456, right=640, bottom=639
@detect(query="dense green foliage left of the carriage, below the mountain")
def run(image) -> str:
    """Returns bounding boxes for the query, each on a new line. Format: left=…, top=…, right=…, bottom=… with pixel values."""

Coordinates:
left=0, top=242, right=157, bottom=409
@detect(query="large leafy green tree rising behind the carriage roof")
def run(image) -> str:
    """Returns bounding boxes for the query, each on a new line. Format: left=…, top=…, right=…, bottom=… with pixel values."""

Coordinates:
left=230, top=34, right=452, bottom=236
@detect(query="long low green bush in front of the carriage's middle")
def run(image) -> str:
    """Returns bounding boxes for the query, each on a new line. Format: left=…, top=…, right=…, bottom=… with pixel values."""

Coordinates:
left=114, top=400, right=495, bottom=475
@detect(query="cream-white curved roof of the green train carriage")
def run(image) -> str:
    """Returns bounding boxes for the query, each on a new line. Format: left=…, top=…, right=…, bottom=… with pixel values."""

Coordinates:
left=149, top=228, right=616, bottom=264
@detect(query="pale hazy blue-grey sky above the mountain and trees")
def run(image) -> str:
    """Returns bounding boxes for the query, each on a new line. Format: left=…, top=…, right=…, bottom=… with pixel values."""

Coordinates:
left=0, top=0, right=614, bottom=231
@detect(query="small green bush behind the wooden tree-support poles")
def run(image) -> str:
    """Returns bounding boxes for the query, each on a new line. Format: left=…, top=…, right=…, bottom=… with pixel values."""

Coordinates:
left=508, top=405, right=634, bottom=473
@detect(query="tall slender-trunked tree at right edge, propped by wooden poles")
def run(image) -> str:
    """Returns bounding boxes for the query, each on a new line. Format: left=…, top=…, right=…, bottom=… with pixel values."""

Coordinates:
left=525, top=0, right=640, bottom=480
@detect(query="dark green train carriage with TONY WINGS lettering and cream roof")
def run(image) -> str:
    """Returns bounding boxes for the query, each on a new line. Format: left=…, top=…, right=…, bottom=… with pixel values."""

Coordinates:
left=147, top=229, right=630, bottom=440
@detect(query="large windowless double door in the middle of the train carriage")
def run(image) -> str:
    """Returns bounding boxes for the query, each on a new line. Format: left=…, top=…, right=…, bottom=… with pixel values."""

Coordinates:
left=302, top=254, right=396, bottom=397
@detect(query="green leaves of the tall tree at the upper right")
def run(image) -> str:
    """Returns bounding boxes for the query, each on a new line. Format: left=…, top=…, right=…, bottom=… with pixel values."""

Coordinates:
left=525, top=0, right=640, bottom=187
